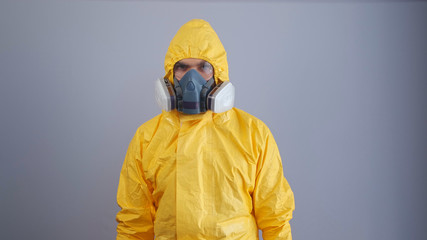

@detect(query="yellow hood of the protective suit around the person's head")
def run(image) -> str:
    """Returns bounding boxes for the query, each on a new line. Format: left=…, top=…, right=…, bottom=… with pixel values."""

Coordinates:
left=164, top=19, right=229, bottom=84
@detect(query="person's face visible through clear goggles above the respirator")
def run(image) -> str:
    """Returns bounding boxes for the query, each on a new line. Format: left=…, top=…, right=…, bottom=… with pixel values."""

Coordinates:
left=173, top=58, right=213, bottom=81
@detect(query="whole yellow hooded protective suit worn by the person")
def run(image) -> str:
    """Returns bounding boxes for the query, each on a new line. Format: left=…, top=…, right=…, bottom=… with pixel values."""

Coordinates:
left=116, top=20, right=294, bottom=240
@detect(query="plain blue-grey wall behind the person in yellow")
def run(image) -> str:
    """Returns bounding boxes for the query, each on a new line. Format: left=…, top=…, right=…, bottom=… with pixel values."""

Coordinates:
left=0, top=1, right=427, bottom=240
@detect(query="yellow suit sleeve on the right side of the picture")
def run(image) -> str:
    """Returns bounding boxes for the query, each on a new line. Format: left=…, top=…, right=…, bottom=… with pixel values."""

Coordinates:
left=252, top=131, right=295, bottom=240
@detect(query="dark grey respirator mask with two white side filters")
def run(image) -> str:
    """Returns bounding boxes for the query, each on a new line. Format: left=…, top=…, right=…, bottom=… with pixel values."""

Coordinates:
left=155, top=69, right=234, bottom=114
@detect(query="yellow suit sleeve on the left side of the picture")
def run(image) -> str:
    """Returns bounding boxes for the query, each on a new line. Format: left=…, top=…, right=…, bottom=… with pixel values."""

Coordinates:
left=116, top=131, right=155, bottom=240
